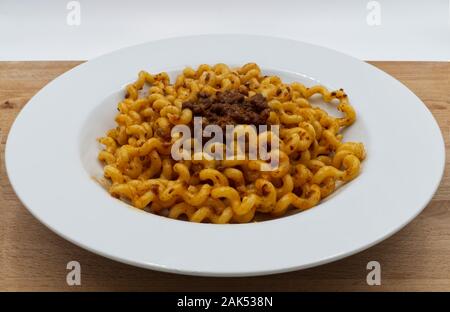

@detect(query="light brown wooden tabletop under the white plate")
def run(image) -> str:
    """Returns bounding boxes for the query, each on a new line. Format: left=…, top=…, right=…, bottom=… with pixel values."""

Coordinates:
left=0, top=62, right=450, bottom=291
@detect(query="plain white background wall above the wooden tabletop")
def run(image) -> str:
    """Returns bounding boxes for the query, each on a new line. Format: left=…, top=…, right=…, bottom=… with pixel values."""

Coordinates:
left=0, top=0, right=450, bottom=61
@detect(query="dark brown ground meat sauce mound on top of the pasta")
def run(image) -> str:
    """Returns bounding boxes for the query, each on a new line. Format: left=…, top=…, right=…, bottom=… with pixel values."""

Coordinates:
left=183, top=90, right=269, bottom=131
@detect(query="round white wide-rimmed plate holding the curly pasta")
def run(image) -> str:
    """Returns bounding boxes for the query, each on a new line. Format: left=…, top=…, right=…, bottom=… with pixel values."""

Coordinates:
left=6, top=35, right=445, bottom=276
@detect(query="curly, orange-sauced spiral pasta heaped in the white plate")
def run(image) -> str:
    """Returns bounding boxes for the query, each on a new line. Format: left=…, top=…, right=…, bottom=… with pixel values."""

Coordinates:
left=98, top=63, right=366, bottom=224
